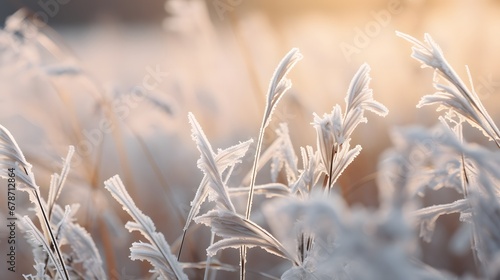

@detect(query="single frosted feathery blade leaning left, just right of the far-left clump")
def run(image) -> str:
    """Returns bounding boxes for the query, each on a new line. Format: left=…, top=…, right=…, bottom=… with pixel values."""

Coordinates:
left=104, top=176, right=187, bottom=279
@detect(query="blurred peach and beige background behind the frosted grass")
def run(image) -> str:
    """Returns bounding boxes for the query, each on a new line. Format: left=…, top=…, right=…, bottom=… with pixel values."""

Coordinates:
left=0, top=0, right=500, bottom=279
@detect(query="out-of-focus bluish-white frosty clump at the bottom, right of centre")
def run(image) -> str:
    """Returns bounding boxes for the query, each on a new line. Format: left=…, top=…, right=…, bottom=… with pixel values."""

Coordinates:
left=265, top=194, right=446, bottom=279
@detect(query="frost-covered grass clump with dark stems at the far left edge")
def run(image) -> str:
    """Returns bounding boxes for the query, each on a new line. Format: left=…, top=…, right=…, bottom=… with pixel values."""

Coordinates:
left=0, top=126, right=106, bottom=279
